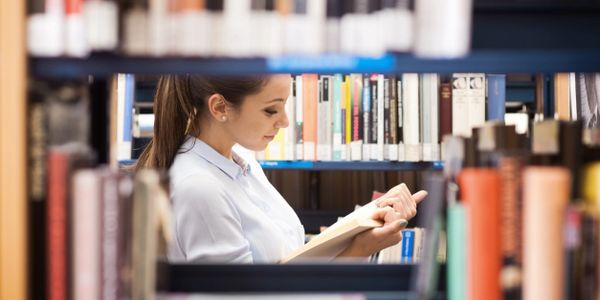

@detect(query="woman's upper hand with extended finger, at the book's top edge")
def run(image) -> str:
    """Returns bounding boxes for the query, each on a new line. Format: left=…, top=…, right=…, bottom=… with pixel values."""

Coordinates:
left=375, top=183, right=427, bottom=220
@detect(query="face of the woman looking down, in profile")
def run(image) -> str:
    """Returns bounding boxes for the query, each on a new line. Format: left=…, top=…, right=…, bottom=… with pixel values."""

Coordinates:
left=225, top=74, right=291, bottom=151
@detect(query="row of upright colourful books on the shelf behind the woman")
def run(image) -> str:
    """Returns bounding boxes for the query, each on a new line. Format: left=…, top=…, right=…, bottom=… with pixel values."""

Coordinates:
left=123, top=73, right=529, bottom=162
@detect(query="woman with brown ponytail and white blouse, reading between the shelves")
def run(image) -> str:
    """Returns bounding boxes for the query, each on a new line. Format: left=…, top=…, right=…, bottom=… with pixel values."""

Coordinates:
left=136, top=75, right=426, bottom=263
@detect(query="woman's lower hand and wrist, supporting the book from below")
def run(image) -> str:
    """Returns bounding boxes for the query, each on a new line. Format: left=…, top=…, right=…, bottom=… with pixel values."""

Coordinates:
left=338, top=206, right=407, bottom=257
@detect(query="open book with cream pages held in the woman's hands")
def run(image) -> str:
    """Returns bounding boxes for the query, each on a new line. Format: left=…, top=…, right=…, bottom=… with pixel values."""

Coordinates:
left=281, top=201, right=398, bottom=263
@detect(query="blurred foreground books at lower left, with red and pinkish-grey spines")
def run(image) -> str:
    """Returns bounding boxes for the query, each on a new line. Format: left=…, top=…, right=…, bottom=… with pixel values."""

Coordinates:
left=40, top=144, right=171, bottom=299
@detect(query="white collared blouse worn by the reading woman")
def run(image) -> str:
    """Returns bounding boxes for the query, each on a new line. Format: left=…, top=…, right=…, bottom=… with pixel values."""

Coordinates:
left=168, top=137, right=304, bottom=263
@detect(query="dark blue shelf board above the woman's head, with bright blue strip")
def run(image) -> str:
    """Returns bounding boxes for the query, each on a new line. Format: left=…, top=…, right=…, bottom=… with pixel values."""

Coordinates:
left=30, top=48, right=600, bottom=78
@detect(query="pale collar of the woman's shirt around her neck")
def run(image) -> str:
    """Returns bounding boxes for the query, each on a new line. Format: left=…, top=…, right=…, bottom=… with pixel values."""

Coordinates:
left=180, top=136, right=250, bottom=179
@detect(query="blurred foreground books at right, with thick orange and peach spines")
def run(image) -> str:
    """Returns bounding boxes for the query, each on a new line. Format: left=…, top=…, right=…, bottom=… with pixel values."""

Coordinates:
left=443, top=120, right=600, bottom=299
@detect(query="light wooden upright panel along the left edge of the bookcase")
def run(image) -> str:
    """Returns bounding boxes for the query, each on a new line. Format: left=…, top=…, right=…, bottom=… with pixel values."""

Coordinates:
left=0, top=1, right=27, bottom=299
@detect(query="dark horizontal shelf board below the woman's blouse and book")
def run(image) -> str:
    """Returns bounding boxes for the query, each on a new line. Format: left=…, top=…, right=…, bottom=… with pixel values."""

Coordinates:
left=158, top=263, right=445, bottom=292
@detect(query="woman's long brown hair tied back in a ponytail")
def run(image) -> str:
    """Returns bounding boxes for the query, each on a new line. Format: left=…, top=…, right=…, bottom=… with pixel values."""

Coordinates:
left=134, top=75, right=267, bottom=170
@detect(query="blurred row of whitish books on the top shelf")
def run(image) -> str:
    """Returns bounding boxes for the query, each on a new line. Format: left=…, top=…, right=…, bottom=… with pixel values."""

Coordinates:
left=28, top=0, right=472, bottom=57
